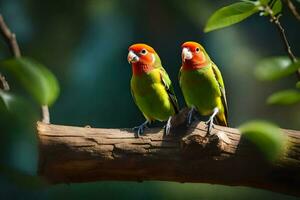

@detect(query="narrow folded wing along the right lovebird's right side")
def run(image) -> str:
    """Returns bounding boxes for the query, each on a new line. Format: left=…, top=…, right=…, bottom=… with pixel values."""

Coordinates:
left=212, top=62, right=228, bottom=126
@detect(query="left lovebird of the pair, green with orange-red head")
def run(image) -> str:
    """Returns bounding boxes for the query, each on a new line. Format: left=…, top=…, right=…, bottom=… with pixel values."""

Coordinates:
left=127, top=44, right=179, bottom=137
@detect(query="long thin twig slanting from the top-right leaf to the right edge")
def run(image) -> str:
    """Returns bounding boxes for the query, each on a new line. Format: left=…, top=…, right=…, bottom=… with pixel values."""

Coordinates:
left=264, top=6, right=300, bottom=80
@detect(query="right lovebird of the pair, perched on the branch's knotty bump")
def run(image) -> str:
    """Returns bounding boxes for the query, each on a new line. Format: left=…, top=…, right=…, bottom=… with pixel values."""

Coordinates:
left=179, top=42, right=228, bottom=134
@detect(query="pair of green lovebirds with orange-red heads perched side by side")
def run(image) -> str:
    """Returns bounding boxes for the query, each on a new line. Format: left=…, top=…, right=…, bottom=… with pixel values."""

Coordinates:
left=127, top=42, right=228, bottom=137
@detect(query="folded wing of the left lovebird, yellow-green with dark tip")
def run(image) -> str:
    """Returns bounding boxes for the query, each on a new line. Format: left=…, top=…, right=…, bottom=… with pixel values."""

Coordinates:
left=160, top=67, right=179, bottom=114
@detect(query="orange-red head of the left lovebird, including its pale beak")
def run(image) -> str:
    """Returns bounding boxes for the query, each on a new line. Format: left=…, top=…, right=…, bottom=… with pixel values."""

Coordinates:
left=127, top=44, right=156, bottom=75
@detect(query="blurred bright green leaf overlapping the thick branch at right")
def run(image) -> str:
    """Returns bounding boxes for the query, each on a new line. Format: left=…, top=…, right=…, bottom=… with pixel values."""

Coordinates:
left=239, top=120, right=287, bottom=161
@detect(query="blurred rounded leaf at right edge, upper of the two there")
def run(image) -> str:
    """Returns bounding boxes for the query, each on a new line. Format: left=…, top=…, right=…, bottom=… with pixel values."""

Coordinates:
left=254, top=56, right=300, bottom=81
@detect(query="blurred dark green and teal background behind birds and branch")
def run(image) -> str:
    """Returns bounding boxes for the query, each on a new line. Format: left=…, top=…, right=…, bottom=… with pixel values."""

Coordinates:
left=0, top=0, right=300, bottom=199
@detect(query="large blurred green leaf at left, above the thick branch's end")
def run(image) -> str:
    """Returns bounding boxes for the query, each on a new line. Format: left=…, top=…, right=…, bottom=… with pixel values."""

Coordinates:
left=0, top=58, right=59, bottom=105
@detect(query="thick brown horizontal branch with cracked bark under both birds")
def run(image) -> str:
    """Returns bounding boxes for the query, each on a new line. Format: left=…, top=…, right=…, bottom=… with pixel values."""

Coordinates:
left=37, top=117, right=300, bottom=196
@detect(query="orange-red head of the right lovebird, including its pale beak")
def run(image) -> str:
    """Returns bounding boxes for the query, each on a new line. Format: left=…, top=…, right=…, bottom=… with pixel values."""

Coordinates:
left=181, top=42, right=207, bottom=70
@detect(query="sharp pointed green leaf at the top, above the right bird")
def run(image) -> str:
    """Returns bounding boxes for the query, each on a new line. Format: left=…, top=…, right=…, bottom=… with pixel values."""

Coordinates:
left=204, top=2, right=259, bottom=32
